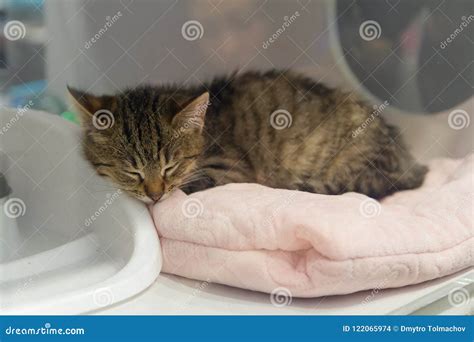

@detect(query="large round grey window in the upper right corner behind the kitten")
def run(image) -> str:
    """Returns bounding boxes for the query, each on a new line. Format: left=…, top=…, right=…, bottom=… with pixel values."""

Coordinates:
left=329, top=0, right=474, bottom=113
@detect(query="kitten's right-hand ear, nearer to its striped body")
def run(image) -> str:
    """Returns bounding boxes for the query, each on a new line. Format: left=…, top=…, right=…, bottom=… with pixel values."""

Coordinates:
left=171, top=92, right=209, bottom=133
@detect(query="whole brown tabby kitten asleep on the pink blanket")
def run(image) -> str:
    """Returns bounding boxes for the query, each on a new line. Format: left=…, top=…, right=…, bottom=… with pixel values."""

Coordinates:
left=69, top=71, right=427, bottom=203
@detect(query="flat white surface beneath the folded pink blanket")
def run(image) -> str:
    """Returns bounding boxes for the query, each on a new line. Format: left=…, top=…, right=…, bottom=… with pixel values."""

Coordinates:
left=95, top=269, right=474, bottom=315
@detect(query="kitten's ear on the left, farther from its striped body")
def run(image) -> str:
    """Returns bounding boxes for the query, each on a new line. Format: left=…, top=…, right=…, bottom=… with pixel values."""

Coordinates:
left=67, top=86, right=116, bottom=124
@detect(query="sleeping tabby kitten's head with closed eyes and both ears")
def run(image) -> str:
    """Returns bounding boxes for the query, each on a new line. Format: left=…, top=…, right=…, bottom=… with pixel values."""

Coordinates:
left=68, top=87, right=209, bottom=203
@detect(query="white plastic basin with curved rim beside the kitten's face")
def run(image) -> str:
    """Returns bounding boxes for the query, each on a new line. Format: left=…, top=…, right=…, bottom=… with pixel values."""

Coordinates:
left=0, top=109, right=161, bottom=314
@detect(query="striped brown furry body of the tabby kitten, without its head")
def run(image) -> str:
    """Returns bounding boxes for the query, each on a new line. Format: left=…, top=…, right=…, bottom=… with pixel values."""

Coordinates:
left=193, top=71, right=426, bottom=197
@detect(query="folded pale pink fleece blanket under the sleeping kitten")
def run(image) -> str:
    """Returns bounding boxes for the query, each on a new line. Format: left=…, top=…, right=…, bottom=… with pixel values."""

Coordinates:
left=152, top=156, right=474, bottom=297
